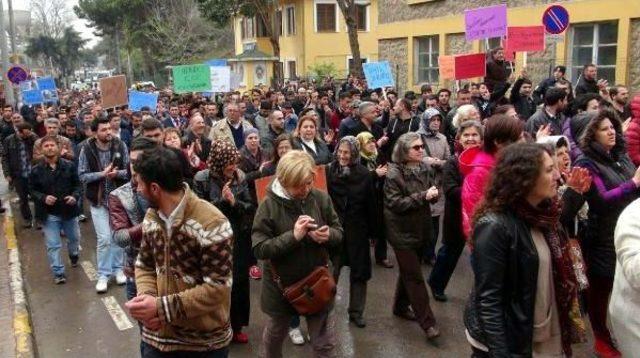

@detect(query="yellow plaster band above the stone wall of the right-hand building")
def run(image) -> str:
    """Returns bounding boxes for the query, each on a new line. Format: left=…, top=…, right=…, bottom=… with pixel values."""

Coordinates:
left=378, top=0, right=569, bottom=24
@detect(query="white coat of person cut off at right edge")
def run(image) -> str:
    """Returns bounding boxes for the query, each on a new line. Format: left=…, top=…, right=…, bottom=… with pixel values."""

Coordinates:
left=609, top=200, right=640, bottom=357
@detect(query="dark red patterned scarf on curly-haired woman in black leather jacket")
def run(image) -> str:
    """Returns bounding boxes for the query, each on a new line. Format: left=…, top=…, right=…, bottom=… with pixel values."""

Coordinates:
left=515, top=198, right=586, bottom=357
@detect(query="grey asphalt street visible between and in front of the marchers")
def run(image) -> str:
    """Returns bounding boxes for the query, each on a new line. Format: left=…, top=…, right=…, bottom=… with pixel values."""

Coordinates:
left=16, top=203, right=584, bottom=358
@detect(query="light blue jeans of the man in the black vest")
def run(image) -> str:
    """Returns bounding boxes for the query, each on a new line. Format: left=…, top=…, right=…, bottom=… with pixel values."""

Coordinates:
left=91, top=205, right=124, bottom=279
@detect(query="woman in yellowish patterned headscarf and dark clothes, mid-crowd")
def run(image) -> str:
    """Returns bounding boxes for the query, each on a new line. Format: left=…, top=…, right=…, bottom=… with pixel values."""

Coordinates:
left=356, top=132, right=393, bottom=268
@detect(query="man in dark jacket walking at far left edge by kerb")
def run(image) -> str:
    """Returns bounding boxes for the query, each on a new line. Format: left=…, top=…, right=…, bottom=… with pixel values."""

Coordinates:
left=2, top=122, right=38, bottom=221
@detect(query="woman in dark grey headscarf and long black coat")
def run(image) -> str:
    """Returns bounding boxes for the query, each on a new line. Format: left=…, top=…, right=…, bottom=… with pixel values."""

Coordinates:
left=327, top=136, right=375, bottom=328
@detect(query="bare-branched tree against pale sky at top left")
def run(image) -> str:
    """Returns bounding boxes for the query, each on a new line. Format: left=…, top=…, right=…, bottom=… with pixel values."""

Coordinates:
left=31, top=0, right=71, bottom=39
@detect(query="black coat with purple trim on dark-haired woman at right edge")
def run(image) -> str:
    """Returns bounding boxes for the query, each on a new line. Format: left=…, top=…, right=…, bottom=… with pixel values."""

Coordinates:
left=576, top=143, right=640, bottom=278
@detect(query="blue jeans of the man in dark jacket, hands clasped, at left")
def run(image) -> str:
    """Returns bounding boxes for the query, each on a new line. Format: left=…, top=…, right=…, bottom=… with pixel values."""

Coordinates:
left=42, top=215, right=80, bottom=276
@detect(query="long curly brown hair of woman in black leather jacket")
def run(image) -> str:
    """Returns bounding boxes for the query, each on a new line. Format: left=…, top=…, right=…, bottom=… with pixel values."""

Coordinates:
left=473, top=143, right=554, bottom=224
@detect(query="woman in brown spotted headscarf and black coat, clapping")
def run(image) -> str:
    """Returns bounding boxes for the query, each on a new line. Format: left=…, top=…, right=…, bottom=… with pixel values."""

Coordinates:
left=194, top=140, right=255, bottom=343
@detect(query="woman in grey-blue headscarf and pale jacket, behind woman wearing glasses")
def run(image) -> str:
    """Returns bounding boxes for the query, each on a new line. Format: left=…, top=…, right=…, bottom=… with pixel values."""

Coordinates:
left=418, top=108, right=449, bottom=265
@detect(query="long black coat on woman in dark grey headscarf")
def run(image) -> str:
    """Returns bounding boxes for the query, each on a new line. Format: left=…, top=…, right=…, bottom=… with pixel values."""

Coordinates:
left=326, top=161, right=375, bottom=281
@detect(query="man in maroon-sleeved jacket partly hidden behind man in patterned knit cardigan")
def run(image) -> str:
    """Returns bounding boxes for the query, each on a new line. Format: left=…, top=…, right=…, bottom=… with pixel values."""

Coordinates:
left=108, top=137, right=159, bottom=300
